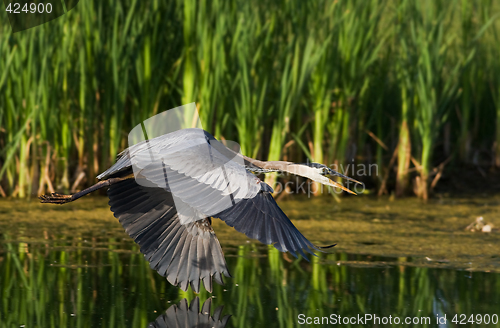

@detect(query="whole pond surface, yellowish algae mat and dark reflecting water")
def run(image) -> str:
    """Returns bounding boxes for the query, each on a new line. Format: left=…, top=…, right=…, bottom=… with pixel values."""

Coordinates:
left=0, top=197, right=500, bottom=327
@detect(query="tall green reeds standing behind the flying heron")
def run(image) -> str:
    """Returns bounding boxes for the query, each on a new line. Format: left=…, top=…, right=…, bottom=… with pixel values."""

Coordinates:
left=0, top=0, right=500, bottom=198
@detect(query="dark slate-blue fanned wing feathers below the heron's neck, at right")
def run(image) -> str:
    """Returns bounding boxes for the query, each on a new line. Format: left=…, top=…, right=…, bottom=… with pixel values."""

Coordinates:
left=214, top=190, right=320, bottom=259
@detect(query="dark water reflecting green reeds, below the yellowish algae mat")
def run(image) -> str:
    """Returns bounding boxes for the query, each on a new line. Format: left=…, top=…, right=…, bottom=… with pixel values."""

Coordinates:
left=0, top=196, right=500, bottom=327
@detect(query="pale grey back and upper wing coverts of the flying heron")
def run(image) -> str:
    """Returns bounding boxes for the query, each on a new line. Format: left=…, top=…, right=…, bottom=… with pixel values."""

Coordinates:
left=98, top=129, right=260, bottom=224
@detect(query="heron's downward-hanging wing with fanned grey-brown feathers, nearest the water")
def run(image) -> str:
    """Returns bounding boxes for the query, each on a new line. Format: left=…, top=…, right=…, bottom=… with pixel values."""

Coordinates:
left=108, top=179, right=231, bottom=292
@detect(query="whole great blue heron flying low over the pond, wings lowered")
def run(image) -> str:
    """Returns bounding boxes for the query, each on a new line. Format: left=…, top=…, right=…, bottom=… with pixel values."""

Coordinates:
left=40, top=129, right=359, bottom=292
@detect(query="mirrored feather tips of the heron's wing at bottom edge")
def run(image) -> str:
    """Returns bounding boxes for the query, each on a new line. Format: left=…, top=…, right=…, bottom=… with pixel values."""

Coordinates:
left=148, top=297, right=231, bottom=328
